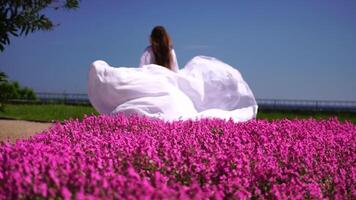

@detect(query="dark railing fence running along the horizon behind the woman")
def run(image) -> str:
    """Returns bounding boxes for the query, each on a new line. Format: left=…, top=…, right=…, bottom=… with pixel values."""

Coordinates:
left=2, top=92, right=356, bottom=112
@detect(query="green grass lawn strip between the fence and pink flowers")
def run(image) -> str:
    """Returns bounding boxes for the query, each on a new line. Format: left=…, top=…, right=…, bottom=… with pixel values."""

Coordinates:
left=0, top=104, right=356, bottom=123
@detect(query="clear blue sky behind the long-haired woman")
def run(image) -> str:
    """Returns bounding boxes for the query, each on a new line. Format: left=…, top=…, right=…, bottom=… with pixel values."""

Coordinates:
left=0, top=0, right=356, bottom=100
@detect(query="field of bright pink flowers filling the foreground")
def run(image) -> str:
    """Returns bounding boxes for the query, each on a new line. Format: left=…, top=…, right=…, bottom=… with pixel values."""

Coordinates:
left=0, top=115, right=356, bottom=199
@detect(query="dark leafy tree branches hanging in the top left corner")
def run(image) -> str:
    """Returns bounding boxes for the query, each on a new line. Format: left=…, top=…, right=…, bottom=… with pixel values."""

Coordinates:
left=0, top=0, right=80, bottom=51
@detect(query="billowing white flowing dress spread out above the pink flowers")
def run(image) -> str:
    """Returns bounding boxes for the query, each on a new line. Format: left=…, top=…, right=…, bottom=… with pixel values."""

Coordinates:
left=88, top=48, right=258, bottom=122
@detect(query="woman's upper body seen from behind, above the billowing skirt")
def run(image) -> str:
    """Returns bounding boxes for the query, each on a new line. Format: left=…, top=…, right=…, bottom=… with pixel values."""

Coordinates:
left=140, top=26, right=179, bottom=72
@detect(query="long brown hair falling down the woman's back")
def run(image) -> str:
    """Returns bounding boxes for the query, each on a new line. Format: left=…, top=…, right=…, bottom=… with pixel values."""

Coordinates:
left=150, top=26, right=172, bottom=69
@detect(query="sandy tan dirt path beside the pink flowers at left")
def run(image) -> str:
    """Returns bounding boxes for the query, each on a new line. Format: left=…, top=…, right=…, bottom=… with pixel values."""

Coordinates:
left=0, top=119, right=52, bottom=141
